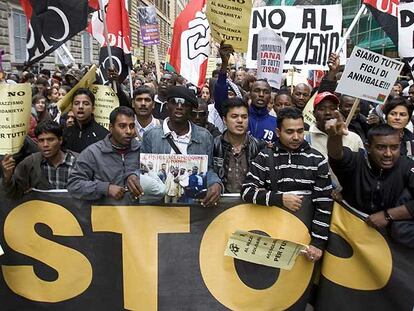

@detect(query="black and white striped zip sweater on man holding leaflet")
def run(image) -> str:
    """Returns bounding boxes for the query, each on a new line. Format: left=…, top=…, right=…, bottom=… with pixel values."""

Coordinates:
left=241, top=142, right=333, bottom=249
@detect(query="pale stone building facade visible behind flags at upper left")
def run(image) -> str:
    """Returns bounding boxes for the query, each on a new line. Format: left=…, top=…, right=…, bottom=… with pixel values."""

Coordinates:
left=0, top=0, right=188, bottom=72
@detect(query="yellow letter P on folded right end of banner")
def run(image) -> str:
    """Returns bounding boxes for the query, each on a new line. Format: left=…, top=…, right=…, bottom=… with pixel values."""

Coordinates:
left=322, top=203, right=392, bottom=290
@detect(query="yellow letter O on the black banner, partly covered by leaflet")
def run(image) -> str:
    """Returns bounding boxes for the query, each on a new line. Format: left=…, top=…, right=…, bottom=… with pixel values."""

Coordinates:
left=200, top=204, right=313, bottom=311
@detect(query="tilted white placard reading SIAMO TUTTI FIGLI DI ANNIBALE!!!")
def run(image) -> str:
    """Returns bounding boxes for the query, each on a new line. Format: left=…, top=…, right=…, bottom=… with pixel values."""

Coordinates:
left=336, top=46, right=404, bottom=104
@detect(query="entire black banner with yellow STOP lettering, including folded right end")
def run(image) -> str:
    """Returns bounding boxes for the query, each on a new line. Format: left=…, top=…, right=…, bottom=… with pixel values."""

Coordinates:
left=0, top=193, right=414, bottom=311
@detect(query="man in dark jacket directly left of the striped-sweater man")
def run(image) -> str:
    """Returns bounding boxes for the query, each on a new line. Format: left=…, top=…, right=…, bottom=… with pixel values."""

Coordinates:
left=213, top=98, right=264, bottom=193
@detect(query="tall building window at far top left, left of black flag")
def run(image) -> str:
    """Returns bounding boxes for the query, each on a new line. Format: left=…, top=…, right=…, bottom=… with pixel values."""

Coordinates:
left=9, top=10, right=27, bottom=63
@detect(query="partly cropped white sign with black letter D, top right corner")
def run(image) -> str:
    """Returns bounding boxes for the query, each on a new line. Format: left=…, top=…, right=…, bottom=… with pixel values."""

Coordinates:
left=398, top=2, right=414, bottom=57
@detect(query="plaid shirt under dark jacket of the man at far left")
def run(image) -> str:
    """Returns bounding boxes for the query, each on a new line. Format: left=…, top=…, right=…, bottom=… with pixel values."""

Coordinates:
left=41, top=152, right=76, bottom=189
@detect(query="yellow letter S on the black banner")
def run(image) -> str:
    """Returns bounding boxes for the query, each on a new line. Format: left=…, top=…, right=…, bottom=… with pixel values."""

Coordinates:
left=2, top=200, right=92, bottom=302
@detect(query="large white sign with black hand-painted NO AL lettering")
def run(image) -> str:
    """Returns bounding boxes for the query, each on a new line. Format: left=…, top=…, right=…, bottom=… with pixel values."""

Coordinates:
left=246, top=4, right=346, bottom=70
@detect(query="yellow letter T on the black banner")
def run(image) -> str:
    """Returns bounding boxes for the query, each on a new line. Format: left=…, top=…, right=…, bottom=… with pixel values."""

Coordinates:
left=92, top=206, right=190, bottom=311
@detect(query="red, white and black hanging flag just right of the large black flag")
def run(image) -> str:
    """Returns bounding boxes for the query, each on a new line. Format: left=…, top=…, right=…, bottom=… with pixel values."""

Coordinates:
left=88, top=0, right=132, bottom=84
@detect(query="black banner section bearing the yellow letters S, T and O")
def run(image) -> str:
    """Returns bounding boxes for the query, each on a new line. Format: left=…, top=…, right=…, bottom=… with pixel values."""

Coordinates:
left=0, top=194, right=314, bottom=310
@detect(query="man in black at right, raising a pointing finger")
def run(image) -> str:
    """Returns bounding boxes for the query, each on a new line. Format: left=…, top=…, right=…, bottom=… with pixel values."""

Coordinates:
left=326, top=119, right=414, bottom=247
